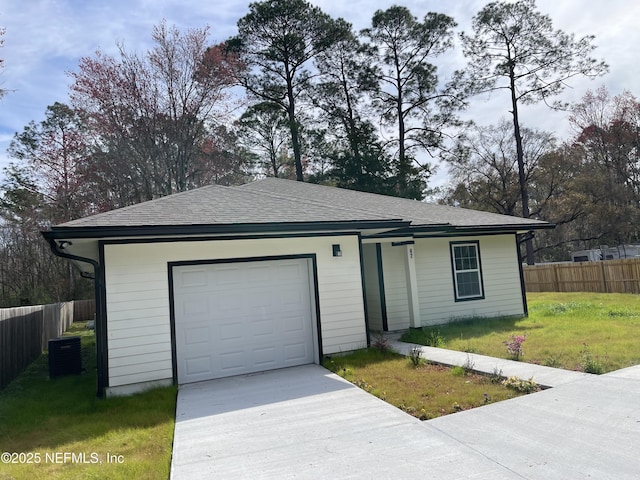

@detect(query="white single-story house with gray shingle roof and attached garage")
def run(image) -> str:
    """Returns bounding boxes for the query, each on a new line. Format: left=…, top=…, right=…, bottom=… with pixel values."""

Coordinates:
left=43, top=178, right=552, bottom=395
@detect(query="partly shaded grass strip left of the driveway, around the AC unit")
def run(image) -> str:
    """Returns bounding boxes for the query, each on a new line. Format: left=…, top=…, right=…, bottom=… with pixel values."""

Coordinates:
left=0, top=323, right=176, bottom=480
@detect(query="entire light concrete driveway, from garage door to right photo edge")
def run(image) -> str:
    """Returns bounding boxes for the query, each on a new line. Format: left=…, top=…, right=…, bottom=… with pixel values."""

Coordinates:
left=171, top=365, right=640, bottom=480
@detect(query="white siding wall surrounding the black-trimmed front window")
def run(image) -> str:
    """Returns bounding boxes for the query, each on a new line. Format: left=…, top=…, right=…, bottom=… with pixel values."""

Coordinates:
left=416, top=235, right=524, bottom=326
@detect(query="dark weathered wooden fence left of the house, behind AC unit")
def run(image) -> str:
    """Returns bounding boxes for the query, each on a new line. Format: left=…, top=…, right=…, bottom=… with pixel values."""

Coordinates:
left=0, top=300, right=95, bottom=388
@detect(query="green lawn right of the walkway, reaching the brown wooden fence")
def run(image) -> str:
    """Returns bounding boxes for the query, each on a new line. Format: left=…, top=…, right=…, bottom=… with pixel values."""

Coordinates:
left=401, top=293, right=640, bottom=373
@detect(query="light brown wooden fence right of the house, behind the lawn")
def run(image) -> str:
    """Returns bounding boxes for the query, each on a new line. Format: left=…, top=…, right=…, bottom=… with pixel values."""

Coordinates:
left=524, top=258, right=640, bottom=293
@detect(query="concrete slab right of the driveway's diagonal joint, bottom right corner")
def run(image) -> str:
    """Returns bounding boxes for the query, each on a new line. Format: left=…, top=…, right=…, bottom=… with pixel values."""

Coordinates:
left=427, top=367, right=640, bottom=480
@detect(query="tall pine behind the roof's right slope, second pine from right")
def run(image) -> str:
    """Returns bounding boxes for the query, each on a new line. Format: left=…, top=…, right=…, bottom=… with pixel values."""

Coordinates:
left=362, top=6, right=463, bottom=199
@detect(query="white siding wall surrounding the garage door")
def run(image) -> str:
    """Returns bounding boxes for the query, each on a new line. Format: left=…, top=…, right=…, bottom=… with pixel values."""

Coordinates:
left=104, top=236, right=366, bottom=387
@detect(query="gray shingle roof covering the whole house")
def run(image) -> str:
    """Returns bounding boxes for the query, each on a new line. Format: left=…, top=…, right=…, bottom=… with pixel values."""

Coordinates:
left=51, top=178, right=547, bottom=229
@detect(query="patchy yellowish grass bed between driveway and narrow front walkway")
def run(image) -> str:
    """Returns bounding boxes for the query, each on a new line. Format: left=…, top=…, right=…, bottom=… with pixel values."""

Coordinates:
left=323, top=348, right=519, bottom=420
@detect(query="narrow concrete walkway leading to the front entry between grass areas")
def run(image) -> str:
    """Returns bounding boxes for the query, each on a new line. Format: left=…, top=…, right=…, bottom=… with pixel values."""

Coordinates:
left=388, top=335, right=593, bottom=388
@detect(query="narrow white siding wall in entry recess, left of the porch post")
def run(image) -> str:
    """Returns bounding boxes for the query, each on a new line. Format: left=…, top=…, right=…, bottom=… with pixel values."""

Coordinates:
left=382, top=243, right=409, bottom=332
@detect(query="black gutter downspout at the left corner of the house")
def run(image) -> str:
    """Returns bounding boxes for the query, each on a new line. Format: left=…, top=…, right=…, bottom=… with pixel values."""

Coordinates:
left=43, top=236, right=107, bottom=398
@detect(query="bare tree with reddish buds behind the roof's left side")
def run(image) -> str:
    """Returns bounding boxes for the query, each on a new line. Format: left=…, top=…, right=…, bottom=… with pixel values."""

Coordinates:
left=71, top=22, right=248, bottom=206
